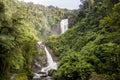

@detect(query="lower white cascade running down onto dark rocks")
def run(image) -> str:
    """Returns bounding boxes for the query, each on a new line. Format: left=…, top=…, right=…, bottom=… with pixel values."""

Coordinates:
left=33, top=42, right=57, bottom=80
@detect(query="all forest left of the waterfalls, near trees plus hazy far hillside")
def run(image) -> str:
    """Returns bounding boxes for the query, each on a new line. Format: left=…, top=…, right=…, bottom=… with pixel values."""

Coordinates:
left=0, top=0, right=76, bottom=80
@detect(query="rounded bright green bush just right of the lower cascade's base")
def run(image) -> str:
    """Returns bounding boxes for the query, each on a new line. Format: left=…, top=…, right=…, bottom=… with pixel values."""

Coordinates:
left=54, top=52, right=92, bottom=80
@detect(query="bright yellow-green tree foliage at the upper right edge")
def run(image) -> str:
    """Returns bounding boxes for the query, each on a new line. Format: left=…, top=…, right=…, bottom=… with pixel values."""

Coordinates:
left=100, top=3, right=120, bottom=33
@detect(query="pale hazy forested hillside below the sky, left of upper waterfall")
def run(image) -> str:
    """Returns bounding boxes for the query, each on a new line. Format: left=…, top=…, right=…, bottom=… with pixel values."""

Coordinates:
left=3, top=0, right=74, bottom=39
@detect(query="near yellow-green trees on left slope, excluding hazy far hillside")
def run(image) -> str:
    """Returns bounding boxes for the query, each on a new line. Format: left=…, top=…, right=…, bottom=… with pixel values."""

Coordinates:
left=0, top=3, right=38, bottom=80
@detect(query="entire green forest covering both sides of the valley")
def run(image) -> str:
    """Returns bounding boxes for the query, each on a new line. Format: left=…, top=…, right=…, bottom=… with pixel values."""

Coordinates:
left=0, top=0, right=120, bottom=80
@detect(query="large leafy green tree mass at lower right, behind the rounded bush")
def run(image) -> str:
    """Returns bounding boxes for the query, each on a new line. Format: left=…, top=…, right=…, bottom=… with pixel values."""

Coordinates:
left=80, top=35, right=120, bottom=80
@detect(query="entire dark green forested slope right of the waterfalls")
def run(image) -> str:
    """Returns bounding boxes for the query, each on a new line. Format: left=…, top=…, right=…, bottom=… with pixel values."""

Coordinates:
left=46, top=0, right=120, bottom=80
